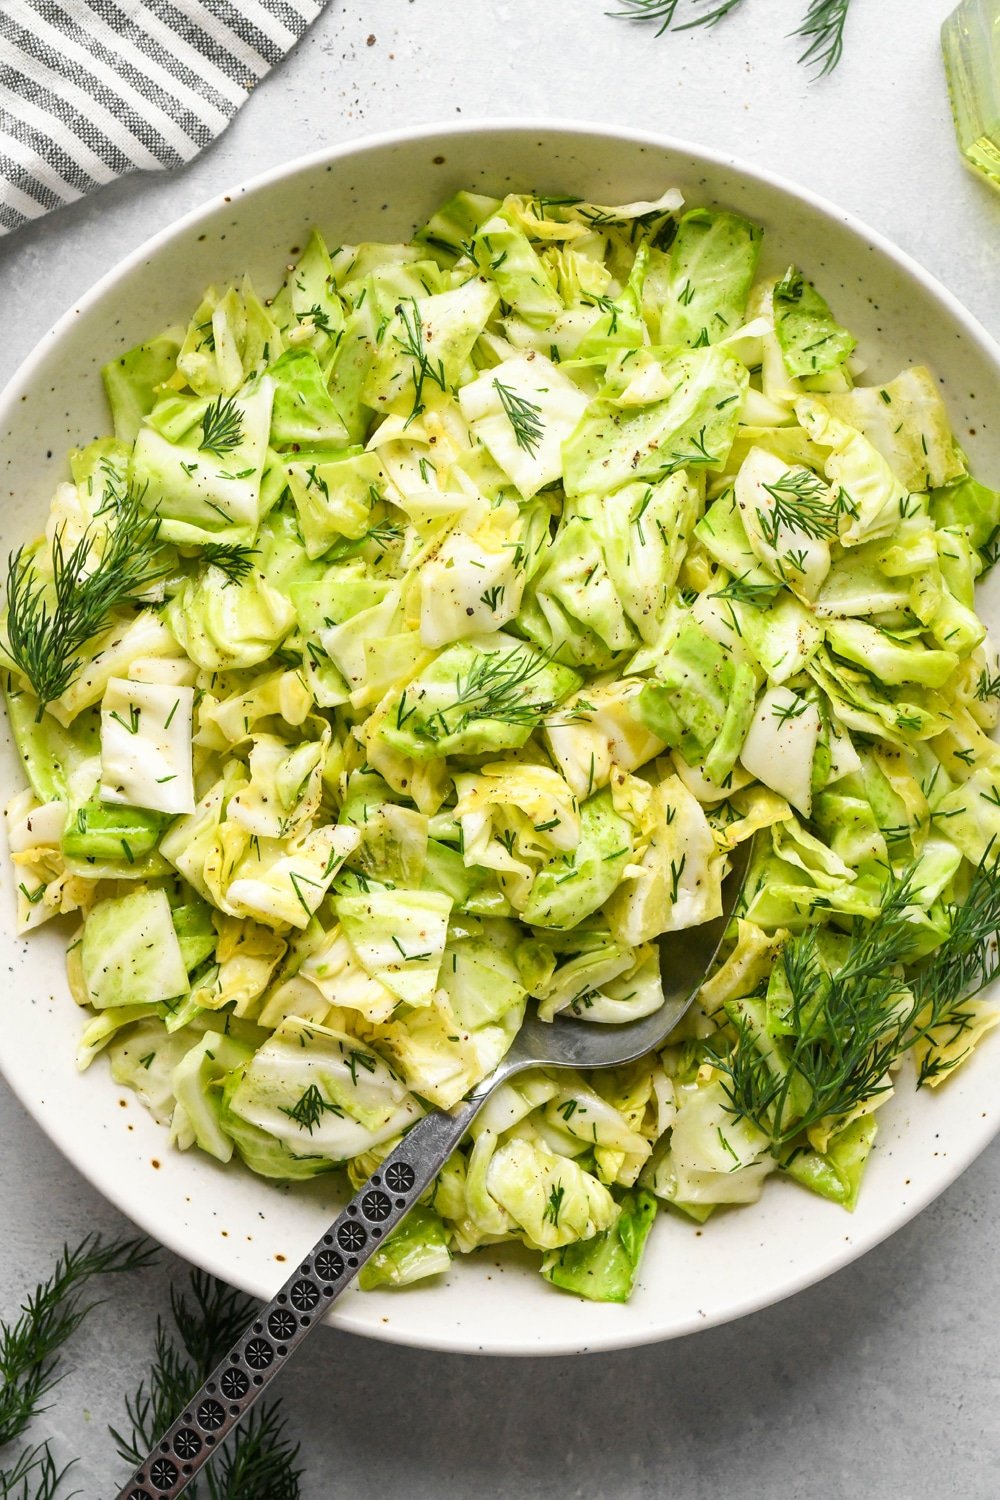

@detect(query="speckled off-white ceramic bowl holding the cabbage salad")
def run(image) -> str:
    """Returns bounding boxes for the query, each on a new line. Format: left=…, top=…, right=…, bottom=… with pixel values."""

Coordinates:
left=0, top=123, right=1000, bottom=1355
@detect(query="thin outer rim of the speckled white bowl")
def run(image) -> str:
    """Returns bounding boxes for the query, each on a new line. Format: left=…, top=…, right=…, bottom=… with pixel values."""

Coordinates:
left=0, top=116, right=1000, bottom=1358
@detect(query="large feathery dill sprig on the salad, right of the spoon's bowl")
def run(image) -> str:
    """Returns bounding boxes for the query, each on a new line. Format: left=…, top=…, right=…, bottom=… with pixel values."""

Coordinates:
left=718, top=849, right=1000, bottom=1145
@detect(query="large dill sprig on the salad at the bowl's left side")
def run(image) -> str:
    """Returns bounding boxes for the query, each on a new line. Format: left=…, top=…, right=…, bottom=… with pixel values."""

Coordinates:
left=7, top=489, right=166, bottom=719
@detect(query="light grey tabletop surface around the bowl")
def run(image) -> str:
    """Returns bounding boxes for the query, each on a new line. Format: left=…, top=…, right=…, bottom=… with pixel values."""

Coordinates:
left=0, top=0, right=1000, bottom=1500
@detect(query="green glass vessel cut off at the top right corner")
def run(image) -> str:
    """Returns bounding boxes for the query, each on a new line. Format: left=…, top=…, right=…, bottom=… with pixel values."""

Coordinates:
left=942, top=0, right=1000, bottom=192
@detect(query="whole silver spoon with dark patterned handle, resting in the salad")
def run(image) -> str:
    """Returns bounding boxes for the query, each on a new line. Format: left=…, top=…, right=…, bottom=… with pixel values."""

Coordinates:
left=117, top=840, right=753, bottom=1500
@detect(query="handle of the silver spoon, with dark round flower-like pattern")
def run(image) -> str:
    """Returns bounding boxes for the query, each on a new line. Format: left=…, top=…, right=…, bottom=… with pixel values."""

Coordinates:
left=117, top=1089, right=479, bottom=1500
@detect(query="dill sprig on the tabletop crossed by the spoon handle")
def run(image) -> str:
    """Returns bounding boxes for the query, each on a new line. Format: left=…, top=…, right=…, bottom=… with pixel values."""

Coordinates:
left=111, top=1271, right=300, bottom=1500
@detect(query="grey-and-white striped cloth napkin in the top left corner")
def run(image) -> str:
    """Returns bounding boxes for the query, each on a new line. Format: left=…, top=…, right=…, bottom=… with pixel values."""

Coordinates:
left=0, top=0, right=325, bottom=234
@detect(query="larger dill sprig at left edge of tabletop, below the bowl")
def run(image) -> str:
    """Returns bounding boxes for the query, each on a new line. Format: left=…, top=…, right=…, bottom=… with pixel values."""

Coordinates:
left=0, top=1235, right=156, bottom=1452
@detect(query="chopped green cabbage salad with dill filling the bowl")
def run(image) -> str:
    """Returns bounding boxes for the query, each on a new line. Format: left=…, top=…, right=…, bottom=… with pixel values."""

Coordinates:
left=3, top=181, right=1000, bottom=1301
